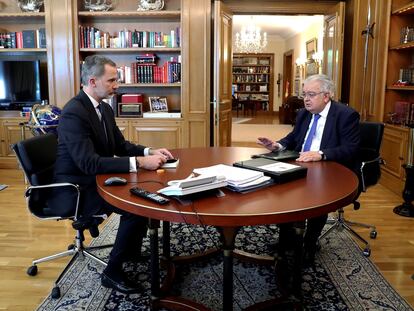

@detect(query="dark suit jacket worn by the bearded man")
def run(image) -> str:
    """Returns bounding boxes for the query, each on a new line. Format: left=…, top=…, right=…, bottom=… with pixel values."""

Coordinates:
left=50, top=91, right=145, bottom=215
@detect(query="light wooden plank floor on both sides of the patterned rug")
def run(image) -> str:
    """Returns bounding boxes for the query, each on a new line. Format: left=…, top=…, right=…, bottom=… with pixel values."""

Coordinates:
left=0, top=112, right=414, bottom=311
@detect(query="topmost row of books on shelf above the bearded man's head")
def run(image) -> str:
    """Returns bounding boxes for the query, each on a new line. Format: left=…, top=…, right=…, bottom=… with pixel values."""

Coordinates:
left=79, top=26, right=181, bottom=49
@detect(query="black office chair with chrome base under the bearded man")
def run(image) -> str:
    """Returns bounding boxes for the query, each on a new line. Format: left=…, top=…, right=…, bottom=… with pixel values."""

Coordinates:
left=12, top=133, right=112, bottom=298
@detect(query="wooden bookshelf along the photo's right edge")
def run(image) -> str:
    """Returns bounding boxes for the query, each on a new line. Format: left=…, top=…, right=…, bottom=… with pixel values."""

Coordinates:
left=381, top=0, right=414, bottom=194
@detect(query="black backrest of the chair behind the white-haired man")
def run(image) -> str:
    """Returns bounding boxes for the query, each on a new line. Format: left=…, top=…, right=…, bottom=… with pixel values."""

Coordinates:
left=359, top=122, right=384, bottom=191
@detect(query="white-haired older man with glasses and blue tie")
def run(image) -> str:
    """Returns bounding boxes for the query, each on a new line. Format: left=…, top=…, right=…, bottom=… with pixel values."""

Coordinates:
left=258, top=75, right=360, bottom=300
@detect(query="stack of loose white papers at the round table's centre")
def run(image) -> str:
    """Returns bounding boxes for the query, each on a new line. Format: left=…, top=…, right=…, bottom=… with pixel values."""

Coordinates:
left=193, top=164, right=273, bottom=192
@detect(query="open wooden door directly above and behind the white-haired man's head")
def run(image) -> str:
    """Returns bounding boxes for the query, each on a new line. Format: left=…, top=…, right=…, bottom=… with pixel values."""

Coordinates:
left=323, top=2, right=345, bottom=100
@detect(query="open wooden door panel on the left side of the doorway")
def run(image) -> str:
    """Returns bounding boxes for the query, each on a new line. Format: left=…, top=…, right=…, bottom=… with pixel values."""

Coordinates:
left=212, top=0, right=233, bottom=146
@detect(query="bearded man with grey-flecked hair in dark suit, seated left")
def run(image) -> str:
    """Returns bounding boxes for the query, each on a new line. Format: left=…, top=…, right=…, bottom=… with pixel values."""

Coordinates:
left=51, top=55, right=172, bottom=294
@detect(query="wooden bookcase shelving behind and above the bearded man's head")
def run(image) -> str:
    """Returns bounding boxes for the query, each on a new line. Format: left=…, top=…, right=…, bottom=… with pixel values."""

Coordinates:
left=74, top=0, right=182, bottom=116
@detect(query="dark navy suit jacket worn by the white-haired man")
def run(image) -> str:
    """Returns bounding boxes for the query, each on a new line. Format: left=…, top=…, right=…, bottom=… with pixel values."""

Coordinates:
left=279, top=101, right=360, bottom=171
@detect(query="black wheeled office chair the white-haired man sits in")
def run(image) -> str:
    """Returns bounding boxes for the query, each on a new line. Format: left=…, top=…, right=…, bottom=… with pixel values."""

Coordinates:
left=319, top=122, right=384, bottom=257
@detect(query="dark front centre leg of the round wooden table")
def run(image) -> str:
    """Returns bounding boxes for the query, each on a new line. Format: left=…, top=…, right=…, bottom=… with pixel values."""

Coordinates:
left=218, top=227, right=239, bottom=310
